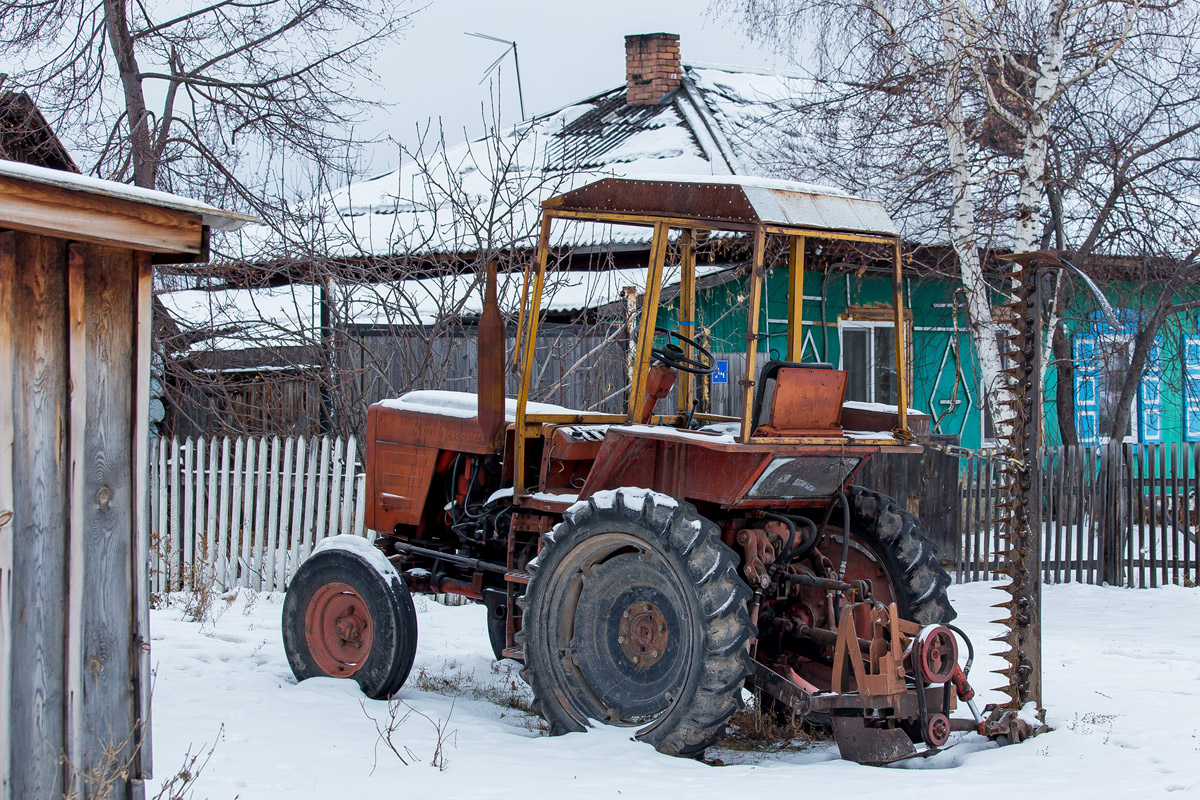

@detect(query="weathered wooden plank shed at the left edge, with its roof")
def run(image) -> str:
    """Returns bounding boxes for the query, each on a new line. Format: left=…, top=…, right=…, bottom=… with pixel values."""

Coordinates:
left=0, top=161, right=250, bottom=800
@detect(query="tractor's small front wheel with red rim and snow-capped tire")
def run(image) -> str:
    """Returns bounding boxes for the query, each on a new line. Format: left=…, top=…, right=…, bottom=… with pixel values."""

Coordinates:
left=283, top=536, right=416, bottom=699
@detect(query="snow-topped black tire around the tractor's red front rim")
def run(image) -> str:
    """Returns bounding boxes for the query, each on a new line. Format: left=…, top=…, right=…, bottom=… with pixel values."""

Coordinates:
left=282, top=536, right=416, bottom=700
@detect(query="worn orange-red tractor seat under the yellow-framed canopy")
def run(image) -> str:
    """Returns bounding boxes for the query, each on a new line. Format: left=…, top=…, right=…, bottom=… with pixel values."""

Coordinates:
left=750, top=361, right=846, bottom=437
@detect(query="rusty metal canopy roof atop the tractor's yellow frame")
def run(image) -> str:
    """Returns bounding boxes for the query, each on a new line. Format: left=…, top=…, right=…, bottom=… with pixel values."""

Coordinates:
left=542, top=175, right=899, bottom=236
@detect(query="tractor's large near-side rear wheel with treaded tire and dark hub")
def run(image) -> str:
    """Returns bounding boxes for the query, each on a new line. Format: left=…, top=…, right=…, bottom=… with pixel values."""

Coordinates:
left=520, top=488, right=756, bottom=757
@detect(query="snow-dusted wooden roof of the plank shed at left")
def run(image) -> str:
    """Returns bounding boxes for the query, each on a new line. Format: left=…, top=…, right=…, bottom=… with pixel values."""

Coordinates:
left=0, top=160, right=257, bottom=255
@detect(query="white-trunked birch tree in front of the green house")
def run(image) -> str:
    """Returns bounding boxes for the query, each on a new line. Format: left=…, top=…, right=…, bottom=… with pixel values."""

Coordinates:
left=726, top=0, right=1174, bottom=433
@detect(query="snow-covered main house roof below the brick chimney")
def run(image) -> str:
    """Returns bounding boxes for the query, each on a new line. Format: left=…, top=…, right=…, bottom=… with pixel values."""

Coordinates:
left=265, top=65, right=854, bottom=257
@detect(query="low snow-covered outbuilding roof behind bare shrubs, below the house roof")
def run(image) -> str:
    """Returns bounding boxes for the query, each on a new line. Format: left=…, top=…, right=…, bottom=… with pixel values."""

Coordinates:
left=157, top=264, right=732, bottom=351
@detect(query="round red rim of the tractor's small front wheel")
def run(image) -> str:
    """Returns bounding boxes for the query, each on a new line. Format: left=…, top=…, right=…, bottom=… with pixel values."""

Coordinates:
left=304, top=583, right=374, bottom=678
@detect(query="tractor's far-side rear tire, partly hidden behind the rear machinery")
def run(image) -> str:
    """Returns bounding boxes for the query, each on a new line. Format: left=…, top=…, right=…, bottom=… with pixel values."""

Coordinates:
left=847, top=486, right=958, bottom=625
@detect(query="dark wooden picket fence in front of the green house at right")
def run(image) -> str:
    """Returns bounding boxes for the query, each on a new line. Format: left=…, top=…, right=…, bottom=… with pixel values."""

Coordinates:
left=955, top=443, right=1200, bottom=587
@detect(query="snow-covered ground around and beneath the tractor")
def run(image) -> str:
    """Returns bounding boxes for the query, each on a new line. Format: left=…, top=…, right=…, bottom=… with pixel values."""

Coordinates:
left=149, top=584, right=1200, bottom=800
